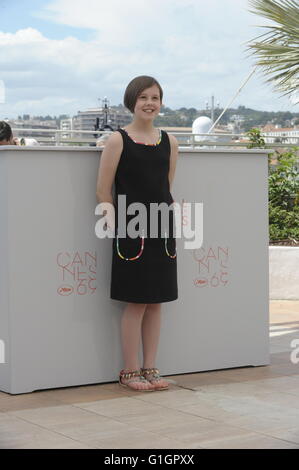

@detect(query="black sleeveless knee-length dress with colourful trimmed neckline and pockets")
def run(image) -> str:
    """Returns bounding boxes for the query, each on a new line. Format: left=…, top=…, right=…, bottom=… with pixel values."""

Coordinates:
left=110, top=129, right=178, bottom=303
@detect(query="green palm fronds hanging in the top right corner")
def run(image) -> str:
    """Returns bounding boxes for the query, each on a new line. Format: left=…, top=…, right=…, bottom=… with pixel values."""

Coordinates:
left=247, top=0, right=299, bottom=96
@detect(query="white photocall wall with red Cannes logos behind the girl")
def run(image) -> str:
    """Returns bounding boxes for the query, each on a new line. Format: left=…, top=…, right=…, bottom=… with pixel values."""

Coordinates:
left=0, top=147, right=269, bottom=394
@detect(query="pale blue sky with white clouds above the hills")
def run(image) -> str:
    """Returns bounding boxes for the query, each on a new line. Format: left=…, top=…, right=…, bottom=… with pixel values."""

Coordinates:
left=0, top=0, right=299, bottom=119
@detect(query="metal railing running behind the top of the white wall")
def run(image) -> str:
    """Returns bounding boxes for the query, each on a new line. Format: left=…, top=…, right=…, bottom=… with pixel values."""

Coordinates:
left=12, top=128, right=299, bottom=149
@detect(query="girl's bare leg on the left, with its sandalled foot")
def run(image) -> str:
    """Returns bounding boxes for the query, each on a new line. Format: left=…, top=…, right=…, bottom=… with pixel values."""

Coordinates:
left=121, top=303, right=152, bottom=390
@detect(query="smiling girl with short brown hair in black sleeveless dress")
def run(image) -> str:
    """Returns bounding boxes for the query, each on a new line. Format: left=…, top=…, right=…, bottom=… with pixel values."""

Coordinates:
left=97, top=76, right=178, bottom=391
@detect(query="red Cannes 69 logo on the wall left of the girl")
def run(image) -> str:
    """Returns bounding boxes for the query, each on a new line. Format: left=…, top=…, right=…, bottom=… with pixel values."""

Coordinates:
left=57, top=251, right=97, bottom=296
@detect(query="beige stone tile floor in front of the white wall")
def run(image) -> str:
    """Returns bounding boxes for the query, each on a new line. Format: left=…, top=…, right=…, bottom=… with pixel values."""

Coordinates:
left=0, top=301, right=299, bottom=449
